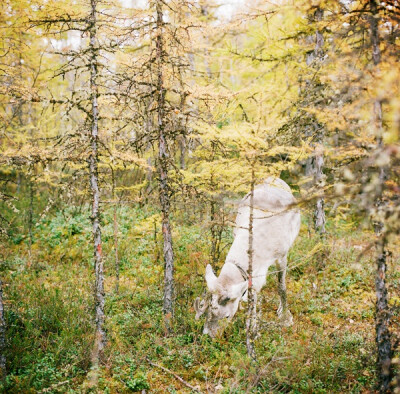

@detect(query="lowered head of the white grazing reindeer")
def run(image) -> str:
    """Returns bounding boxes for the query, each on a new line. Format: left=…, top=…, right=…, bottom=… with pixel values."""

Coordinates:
left=194, top=264, right=247, bottom=337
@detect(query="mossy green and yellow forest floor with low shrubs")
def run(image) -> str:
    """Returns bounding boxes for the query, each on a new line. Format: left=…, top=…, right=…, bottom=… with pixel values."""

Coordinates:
left=0, top=207, right=400, bottom=393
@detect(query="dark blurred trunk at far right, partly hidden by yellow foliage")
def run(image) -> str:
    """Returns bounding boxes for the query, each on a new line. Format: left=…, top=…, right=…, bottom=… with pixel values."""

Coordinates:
left=369, top=0, right=393, bottom=393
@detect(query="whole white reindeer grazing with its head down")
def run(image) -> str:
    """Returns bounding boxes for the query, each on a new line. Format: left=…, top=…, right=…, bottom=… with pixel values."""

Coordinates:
left=194, top=177, right=300, bottom=337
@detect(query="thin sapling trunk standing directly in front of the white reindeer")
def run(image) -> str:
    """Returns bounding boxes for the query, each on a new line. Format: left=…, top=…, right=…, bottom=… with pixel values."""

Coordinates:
left=246, top=163, right=257, bottom=361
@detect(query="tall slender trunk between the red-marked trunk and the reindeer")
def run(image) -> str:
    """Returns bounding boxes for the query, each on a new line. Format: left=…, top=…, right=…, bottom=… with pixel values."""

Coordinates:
left=156, top=0, right=174, bottom=332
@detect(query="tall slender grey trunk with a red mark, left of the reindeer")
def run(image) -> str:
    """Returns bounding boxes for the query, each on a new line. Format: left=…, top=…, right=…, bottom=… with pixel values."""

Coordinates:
left=89, top=0, right=106, bottom=367
